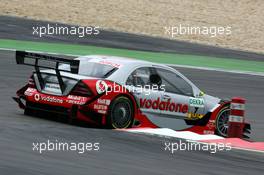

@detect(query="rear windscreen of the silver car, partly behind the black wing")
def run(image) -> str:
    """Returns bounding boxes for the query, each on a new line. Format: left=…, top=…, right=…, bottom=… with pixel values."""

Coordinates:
left=59, top=61, right=118, bottom=78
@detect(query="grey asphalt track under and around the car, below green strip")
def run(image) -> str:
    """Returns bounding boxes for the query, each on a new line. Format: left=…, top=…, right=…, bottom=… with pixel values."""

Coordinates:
left=0, top=16, right=264, bottom=175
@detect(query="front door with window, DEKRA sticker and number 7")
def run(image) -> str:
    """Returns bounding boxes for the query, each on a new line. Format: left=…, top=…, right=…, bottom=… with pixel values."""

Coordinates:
left=155, top=67, right=205, bottom=129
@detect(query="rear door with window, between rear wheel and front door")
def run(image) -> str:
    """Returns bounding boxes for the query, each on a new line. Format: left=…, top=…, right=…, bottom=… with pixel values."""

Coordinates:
left=126, top=67, right=161, bottom=117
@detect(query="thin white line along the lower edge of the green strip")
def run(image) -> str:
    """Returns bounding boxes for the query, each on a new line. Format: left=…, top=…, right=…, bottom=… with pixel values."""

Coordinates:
left=0, top=48, right=264, bottom=77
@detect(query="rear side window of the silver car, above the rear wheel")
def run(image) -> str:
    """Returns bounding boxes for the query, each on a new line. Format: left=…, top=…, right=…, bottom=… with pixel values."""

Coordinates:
left=126, top=67, right=150, bottom=87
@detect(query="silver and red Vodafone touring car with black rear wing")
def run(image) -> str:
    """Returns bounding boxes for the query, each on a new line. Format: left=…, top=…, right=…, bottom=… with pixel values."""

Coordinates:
left=13, top=51, right=250, bottom=137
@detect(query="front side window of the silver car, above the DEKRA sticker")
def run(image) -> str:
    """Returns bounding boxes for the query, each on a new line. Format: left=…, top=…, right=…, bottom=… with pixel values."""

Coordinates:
left=156, top=68, right=193, bottom=96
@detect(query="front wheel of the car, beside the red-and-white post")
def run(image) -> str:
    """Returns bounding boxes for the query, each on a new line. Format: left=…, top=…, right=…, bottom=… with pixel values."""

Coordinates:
left=215, top=106, right=230, bottom=137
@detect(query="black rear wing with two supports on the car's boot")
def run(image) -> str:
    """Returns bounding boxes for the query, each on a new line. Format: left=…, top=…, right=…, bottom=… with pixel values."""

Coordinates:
left=16, top=51, right=80, bottom=92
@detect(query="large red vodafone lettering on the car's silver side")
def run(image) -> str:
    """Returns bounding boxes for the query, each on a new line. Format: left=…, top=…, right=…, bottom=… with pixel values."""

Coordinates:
left=140, top=98, right=188, bottom=113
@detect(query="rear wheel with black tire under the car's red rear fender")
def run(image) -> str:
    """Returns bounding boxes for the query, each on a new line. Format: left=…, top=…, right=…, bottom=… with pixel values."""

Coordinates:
left=107, top=96, right=134, bottom=129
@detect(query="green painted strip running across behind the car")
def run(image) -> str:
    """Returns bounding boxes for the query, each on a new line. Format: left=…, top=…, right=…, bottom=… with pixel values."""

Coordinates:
left=0, top=39, right=264, bottom=72
